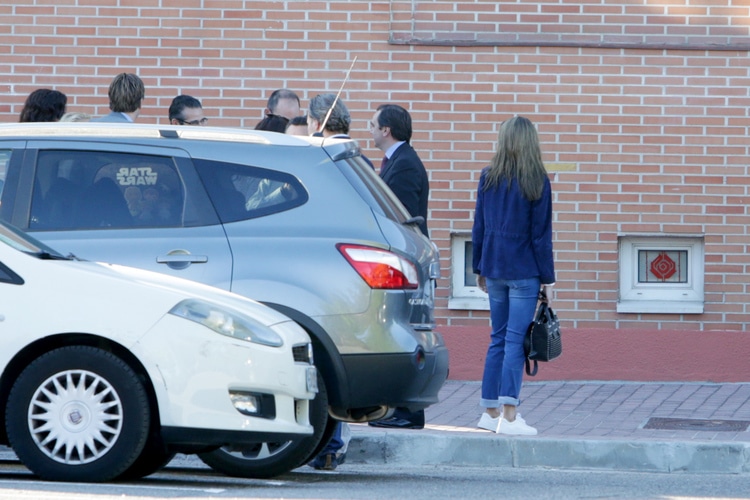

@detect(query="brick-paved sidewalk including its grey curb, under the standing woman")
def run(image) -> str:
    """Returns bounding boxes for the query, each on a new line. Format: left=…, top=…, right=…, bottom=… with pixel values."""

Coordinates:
left=347, top=380, right=750, bottom=474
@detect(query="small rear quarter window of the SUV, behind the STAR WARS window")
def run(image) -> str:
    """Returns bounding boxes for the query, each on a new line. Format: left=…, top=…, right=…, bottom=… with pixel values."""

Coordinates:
left=193, top=159, right=308, bottom=222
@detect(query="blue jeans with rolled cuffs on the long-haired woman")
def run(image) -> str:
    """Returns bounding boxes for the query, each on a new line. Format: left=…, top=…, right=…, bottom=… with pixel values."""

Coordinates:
left=479, top=278, right=540, bottom=408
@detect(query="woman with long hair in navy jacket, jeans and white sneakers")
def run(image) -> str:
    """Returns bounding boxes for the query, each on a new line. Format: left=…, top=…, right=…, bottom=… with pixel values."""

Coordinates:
left=472, top=116, right=555, bottom=435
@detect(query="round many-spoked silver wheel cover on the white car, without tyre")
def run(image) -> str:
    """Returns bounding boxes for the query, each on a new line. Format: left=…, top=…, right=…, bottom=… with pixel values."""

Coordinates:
left=28, top=370, right=123, bottom=465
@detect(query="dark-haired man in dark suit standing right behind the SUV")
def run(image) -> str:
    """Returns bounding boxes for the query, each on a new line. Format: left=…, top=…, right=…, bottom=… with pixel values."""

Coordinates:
left=370, top=104, right=430, bottom=429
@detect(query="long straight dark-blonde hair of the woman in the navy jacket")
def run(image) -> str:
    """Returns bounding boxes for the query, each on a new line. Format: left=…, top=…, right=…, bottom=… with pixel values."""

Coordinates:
left=484, top=116, right=547, bottom=201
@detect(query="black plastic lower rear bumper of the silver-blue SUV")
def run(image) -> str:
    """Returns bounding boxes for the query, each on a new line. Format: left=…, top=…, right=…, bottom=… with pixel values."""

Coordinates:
left=341, top=338, right=448, bottom=411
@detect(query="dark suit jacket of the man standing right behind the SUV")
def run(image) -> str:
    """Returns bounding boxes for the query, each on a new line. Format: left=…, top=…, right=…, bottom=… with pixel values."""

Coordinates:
left=380, top=142, right=430, bottom=237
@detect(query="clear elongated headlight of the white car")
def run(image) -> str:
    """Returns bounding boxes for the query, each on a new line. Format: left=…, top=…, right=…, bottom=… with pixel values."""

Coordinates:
left=169, top=299, right=284, bottom=347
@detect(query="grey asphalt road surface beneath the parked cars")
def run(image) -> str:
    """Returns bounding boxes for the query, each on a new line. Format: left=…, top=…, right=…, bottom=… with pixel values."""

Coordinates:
left=0, top=456, right=750, bottom=500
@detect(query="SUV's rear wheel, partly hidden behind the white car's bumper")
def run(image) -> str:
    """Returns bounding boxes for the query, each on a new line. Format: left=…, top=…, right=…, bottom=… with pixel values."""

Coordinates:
left=198, top=371, right=333, bottom=478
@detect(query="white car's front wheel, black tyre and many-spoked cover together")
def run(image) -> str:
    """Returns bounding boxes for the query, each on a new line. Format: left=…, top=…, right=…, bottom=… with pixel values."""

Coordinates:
left=6, top=346, right=150, bottom=481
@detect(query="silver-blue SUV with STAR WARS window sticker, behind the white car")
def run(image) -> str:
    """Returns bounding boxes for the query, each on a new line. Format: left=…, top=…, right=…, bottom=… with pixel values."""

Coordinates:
left=0, top=123, right=448, bottom=477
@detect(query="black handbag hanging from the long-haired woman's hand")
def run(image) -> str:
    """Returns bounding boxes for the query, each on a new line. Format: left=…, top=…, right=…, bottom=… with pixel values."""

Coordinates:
left=523, top=292, right=562, bottom=377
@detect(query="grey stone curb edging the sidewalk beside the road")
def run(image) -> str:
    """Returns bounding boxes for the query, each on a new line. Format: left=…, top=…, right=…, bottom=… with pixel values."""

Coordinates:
left=346, top=431, right=750, bottom=474
